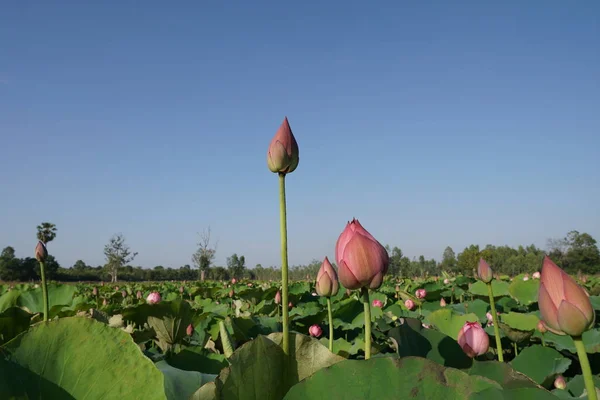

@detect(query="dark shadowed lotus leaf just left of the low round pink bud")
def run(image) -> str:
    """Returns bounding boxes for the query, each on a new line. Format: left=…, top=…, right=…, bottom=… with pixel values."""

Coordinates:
left=388, top=318, right=472, bottom=368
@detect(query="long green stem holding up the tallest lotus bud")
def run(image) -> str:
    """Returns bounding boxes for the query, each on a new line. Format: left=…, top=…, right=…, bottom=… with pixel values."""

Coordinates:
left=279, top=172, right=290, bottom=355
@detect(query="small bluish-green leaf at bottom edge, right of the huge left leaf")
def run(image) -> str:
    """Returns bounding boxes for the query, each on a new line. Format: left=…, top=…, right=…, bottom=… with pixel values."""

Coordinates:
left=156, top=361, right=217, bottom=400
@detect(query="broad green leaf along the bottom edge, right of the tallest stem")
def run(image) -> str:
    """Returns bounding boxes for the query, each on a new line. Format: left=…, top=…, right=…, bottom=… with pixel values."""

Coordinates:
left=284, top=357, right=500, bottom=400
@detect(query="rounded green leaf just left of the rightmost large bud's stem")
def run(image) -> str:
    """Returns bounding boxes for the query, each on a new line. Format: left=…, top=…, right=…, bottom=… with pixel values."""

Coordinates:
left=511, top=345, right=571, bottom=386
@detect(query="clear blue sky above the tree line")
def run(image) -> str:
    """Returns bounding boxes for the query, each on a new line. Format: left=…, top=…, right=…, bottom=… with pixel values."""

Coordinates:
left=0, top=0, right=600, bottom=267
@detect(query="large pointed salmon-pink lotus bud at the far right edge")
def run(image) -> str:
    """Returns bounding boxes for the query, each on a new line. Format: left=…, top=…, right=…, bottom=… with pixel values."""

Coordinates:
left=538, top=256, right=596, bottom=336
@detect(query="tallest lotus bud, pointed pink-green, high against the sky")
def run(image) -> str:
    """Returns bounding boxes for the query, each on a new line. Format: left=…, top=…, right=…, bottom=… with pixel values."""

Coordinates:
left=267, top=117, right=300, bottom=174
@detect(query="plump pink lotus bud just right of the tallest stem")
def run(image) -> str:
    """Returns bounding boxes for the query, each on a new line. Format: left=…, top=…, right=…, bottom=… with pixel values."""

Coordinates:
left=335, top=219, right=390, bottom=290
